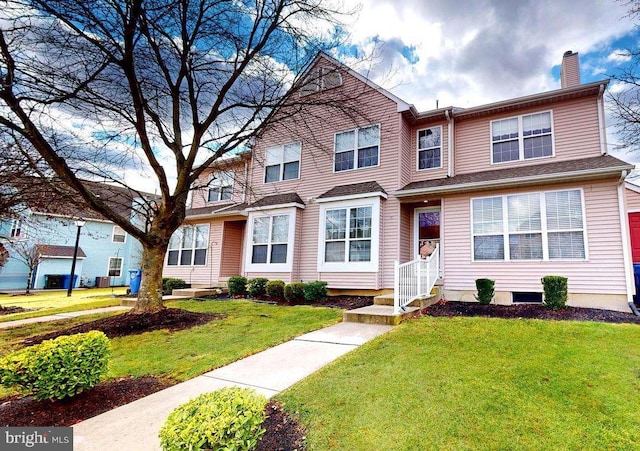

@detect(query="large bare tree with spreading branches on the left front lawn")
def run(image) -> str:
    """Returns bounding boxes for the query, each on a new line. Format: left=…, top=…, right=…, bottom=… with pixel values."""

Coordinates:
left=0, top=0, right=362, bottom=311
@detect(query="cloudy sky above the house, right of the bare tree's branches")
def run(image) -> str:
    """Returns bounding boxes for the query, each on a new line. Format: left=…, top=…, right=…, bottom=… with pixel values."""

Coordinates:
left=341, top=0, right=640, bottom=160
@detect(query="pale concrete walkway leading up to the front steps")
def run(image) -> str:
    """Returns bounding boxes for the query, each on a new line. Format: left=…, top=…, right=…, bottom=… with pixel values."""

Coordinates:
left=73, top=323, right=392, bottom=451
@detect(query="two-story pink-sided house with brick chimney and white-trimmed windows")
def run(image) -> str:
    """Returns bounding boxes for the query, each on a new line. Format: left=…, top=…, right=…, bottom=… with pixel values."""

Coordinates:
left=165, top=52, right=640, bottom=311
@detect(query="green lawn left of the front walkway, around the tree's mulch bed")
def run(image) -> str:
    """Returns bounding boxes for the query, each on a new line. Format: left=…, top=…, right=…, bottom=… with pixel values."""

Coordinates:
left=0, top=301, right=342, bottom=397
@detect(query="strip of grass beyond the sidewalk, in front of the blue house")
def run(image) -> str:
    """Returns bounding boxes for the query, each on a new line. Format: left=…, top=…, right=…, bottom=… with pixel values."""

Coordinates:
left=0, top=287, right=127, bottom=322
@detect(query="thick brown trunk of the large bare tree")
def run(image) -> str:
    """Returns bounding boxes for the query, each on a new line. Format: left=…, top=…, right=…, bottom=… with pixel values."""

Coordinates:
left=133, top=244, right=167, bottom=313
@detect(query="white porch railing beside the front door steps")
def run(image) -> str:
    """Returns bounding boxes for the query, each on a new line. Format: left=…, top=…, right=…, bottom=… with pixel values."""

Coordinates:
left=393, top=246, right=440, bottom=314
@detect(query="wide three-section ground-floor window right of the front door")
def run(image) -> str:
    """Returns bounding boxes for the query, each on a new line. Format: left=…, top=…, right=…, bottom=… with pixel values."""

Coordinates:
left=471, top=189, right=586, bottom=261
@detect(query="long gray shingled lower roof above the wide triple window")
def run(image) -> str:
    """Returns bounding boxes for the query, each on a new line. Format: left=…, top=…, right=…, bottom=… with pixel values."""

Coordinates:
left=394, top=155, right=634, bottom=196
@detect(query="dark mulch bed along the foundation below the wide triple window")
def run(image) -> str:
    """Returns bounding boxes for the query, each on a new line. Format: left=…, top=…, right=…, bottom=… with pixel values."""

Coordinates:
left=421, top=301, right=640, bottom=324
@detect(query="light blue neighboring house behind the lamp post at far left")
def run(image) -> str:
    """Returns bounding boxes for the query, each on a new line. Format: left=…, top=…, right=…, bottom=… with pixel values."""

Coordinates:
left=0, top=181, right=142, bottom=291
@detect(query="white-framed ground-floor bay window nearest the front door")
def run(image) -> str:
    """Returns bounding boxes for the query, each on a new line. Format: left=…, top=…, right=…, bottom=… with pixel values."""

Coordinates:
left=318, top=197, right=380, bottom=272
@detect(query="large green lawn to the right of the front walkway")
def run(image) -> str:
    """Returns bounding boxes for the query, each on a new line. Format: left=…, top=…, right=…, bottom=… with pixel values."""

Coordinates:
left=278, top=318, right=640, bottom=450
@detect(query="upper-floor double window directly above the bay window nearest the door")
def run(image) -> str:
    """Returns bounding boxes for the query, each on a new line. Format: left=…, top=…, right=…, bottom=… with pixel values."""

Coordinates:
left=334, top=125, right=380, bottom=172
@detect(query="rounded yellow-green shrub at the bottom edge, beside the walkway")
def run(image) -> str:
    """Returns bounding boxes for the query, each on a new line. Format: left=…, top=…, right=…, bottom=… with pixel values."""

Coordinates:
left=160, top=387, right=267, bottom=451
